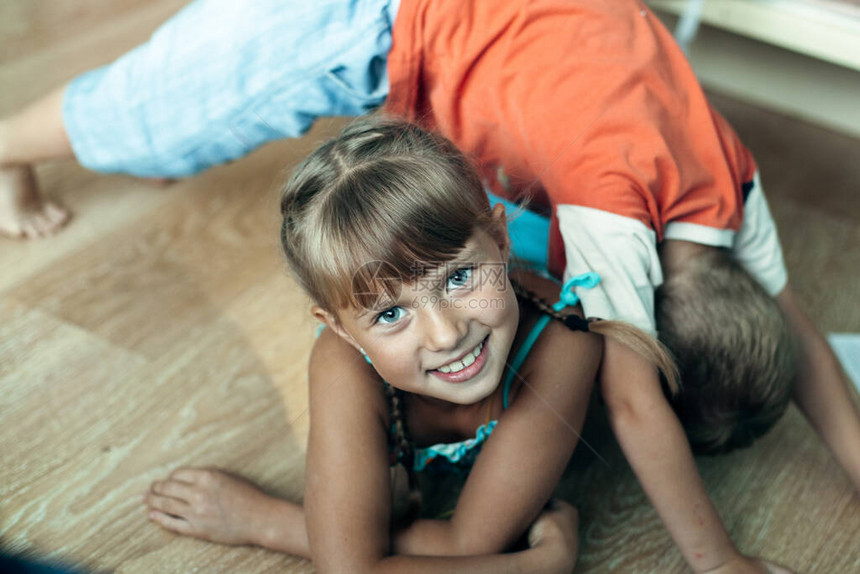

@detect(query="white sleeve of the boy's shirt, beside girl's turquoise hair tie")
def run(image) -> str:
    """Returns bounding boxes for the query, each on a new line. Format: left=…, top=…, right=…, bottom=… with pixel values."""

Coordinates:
left=556, top=205, right=663, bottom=335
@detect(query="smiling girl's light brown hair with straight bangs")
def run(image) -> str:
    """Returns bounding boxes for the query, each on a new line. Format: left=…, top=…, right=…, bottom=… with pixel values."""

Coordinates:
left=281, top=115, right=503, bottom=314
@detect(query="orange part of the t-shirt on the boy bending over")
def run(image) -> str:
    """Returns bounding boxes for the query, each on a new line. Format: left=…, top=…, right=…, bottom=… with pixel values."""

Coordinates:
left=386, top=0, right=756, bottom=275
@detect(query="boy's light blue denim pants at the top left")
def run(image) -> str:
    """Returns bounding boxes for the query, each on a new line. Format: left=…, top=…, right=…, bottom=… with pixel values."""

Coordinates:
left=63, top=0, right=399, bottom=177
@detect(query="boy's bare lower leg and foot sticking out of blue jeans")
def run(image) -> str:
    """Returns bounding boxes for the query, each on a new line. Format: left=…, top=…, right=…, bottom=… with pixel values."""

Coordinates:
left=0, top=87, right=73, bottom=239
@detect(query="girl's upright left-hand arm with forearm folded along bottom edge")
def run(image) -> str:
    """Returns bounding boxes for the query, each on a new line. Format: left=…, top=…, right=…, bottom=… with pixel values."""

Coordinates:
left=305, top=330, right=573, bottom=573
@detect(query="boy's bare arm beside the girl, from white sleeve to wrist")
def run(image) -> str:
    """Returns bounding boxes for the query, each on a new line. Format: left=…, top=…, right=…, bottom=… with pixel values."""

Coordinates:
left=600, top=340, right=755, bottom=572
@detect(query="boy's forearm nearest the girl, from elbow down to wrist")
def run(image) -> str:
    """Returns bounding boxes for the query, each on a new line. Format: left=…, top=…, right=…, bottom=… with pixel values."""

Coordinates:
left=610, top=396, right=737, bottom=572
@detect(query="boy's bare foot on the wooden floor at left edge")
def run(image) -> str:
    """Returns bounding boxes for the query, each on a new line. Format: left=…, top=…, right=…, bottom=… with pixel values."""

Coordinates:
left=0, top=166, right=69, bottom=239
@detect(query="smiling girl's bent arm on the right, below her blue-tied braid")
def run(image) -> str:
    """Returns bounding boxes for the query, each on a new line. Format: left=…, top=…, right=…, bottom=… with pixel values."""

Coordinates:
left=395, top=306, right=601, bottom=555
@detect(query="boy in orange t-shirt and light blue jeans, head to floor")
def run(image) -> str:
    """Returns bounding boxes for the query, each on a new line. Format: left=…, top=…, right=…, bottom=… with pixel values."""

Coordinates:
left=6, top=0, right=860, bottom=516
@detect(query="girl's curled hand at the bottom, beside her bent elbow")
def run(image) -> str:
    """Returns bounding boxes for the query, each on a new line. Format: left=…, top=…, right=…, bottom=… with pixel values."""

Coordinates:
left=528, top=499, right=579, bottom=572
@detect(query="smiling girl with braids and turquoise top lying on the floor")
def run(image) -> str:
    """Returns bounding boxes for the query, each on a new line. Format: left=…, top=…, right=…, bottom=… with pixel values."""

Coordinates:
left=147, top=117, right=788, bottom=572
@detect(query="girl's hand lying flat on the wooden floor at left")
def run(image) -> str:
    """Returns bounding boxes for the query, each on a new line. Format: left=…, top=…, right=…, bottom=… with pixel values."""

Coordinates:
left=144, top=468, right=273, bottom=544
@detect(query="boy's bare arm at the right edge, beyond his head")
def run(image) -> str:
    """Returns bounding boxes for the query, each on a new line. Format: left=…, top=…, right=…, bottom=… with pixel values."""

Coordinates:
left=776, top=286, right=860, bottom=493
